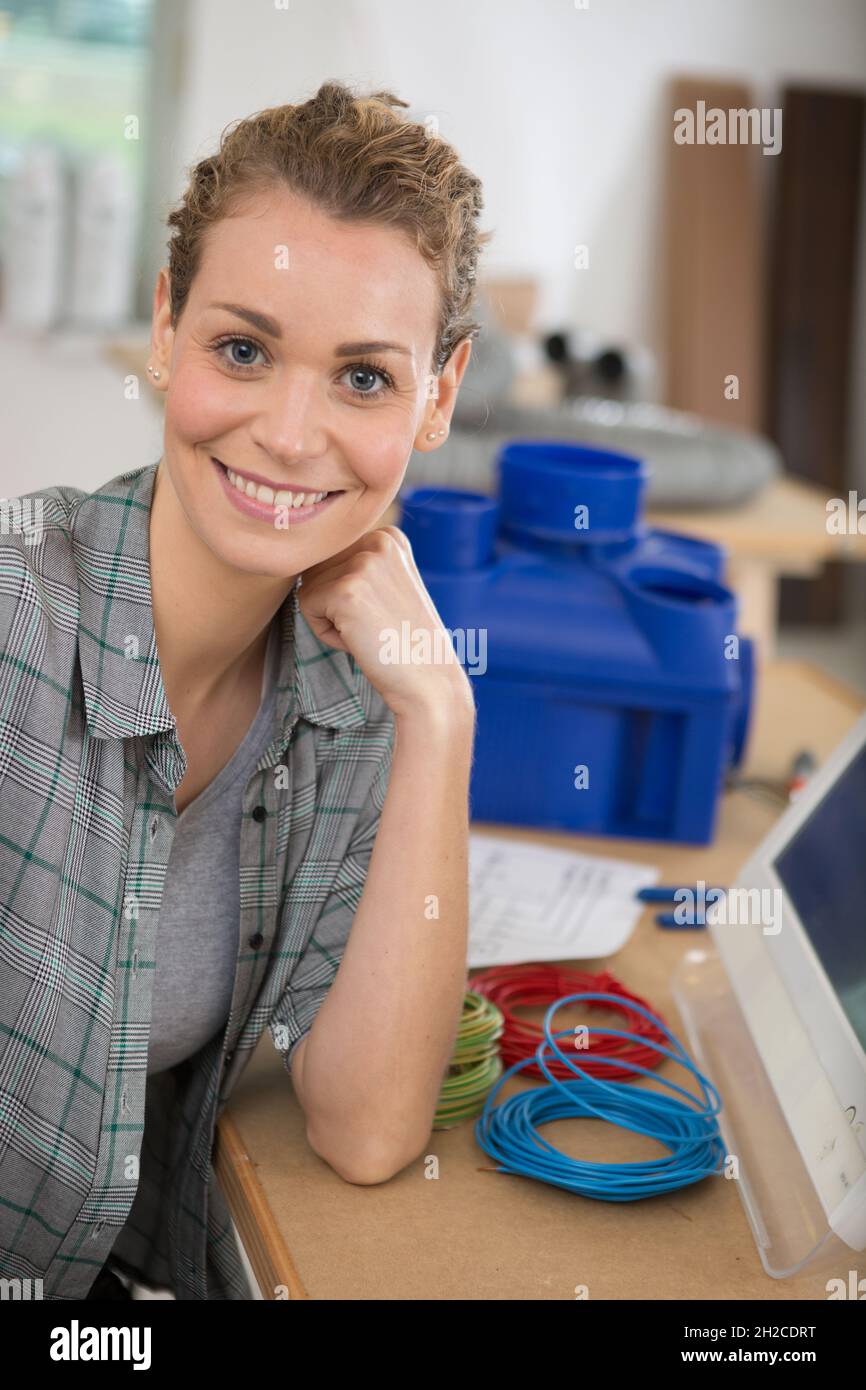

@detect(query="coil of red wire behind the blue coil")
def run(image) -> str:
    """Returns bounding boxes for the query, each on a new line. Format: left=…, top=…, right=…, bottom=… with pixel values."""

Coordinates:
left=468, top=963, right=667, bottom=1081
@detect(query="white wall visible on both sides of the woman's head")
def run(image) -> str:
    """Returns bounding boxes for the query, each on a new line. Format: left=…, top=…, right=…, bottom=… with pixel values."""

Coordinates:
left=0, top=0, right=866, bottom=517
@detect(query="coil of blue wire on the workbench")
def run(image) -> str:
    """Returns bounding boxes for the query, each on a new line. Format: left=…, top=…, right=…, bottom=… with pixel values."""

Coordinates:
left=475, top=994, right=726, bottom=1202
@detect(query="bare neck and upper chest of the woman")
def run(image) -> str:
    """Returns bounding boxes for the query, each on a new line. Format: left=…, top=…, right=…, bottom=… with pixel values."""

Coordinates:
left=150, top=461, right=293, bottom=709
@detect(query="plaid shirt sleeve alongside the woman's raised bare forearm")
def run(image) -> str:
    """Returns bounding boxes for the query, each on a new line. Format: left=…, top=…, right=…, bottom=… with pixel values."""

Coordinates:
left=268, top=724, right=395, bottom=1072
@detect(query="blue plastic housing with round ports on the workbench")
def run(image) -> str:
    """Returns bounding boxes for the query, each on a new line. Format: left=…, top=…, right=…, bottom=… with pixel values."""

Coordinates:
left=399, top=439, right=753, bottom=844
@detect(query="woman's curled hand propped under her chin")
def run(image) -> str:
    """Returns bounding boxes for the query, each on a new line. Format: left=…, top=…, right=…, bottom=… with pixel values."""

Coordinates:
left=299, top=525, right=475, bottom=719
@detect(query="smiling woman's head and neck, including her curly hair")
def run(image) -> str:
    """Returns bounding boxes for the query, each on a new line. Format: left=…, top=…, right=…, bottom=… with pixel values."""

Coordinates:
left=142, top=82, right=489, bottom=705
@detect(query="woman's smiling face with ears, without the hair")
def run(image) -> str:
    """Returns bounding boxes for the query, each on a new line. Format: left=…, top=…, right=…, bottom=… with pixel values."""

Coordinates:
left=152, top=189, right=471, bottom=578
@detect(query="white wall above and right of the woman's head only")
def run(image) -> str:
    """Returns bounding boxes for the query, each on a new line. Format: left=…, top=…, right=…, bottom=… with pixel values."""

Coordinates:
left=155, top=0, right=866, bottom=346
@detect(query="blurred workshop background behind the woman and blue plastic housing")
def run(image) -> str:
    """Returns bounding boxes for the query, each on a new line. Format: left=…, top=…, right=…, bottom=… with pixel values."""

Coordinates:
left=0, top=0, right=866, bottom=694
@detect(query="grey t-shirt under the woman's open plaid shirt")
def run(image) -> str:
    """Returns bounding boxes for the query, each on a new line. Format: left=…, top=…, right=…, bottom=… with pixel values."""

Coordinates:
left=147, top=623, right=279, bottom=1074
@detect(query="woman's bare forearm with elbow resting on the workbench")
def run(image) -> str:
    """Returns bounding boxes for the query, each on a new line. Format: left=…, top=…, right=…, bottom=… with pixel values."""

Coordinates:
left=297, top=689, right=474, bottom=1180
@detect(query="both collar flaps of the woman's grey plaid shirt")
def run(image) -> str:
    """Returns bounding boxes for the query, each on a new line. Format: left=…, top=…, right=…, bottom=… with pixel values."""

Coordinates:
left=72, top=463, right=366, bottom=752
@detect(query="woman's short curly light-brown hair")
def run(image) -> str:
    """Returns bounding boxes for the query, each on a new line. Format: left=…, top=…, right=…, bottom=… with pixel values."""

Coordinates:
left=167, top=81, right=493, bottom=377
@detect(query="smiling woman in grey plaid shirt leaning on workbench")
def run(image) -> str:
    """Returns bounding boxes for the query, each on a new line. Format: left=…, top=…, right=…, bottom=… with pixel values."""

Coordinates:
left=0, top=82, right=489, bottom=1298
